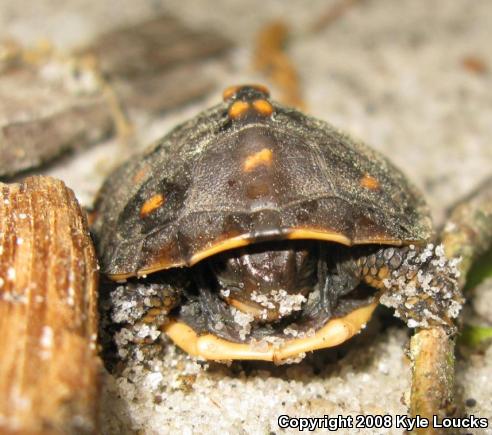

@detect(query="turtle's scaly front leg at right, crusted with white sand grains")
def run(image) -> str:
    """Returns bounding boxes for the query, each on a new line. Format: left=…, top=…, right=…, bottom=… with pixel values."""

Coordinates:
left=357, top=244, right=463, bottom=332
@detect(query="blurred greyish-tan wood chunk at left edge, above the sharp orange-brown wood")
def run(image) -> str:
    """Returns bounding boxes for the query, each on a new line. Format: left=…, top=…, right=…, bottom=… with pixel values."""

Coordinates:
left=0, top=67, right=113, bottom=178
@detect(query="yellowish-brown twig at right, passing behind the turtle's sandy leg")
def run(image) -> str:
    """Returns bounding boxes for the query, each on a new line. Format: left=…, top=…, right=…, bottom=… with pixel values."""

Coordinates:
left=410, top=178, right=492, bottom=434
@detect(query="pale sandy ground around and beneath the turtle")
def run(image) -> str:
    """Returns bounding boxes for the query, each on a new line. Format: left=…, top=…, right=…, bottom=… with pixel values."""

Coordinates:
left=0, top=0, right=492, bottom=434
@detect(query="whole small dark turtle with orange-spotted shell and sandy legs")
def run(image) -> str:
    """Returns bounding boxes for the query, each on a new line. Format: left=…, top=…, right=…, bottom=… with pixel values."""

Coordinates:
left=92, top=85, right=461, bottom=363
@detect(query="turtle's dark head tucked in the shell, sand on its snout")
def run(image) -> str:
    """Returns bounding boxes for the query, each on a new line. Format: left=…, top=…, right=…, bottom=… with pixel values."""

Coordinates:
left=210, top=241, right=317, bottom=322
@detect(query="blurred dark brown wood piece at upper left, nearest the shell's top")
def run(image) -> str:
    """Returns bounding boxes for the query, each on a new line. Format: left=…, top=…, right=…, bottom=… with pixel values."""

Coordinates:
left=81, top=15, right=231, bottom=114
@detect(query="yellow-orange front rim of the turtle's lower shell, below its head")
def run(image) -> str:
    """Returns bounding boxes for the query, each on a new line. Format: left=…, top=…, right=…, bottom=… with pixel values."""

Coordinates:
left=162, top=300, right=378, bottom=363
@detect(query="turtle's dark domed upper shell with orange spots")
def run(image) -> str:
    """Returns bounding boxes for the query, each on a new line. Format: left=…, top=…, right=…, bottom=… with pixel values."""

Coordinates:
left=93, top=87, right=431, bottom=280
